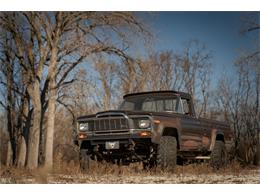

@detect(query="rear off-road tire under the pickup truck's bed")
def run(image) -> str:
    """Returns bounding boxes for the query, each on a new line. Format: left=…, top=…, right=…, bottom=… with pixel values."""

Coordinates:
left=210, top=140, right=227, bottom=169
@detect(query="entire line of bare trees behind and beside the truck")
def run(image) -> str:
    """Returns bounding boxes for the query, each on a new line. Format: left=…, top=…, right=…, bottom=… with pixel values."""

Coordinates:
left=0, top=12, right=260, bottom=169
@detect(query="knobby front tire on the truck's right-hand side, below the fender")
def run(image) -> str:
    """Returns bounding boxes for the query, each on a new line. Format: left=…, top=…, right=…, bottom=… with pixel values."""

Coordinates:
left=157, top=136, right=177, bottom=171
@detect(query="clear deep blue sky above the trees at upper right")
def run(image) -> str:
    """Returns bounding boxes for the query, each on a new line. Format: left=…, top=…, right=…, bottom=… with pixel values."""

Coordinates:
left=138, top=12, right=255, bottom=85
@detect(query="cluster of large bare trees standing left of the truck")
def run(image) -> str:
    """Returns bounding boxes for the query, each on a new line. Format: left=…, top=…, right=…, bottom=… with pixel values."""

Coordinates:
left=0, top=12, right=150, bottom=169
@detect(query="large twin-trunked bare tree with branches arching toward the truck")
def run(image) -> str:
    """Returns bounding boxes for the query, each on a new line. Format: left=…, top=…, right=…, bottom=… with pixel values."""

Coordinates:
left=1, top=12, right=149, bottom=169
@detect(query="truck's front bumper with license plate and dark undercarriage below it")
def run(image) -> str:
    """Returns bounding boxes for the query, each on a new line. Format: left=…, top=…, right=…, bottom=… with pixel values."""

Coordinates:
left=78, top=130, right=153, bottom=163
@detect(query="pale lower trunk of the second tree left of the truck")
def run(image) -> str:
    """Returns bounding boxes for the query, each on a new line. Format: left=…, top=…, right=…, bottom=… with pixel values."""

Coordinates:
left=27, top=79, right=41, bottom=169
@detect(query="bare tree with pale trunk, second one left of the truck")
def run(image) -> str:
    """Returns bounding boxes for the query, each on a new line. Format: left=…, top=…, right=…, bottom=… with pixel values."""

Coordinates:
left=1, top=13, right=51, bottom=169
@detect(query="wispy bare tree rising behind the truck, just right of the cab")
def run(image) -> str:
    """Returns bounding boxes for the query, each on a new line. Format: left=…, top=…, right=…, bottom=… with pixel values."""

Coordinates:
left=173, top=40, right=212, bottom=116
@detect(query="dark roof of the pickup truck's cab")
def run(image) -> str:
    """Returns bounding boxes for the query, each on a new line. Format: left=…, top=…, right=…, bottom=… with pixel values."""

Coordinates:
left=123, top=90, right=191, bottom=99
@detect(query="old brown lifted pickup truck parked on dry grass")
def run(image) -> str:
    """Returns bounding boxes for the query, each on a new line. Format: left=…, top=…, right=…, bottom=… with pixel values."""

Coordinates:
left=75, top=91, right=233, bottom=170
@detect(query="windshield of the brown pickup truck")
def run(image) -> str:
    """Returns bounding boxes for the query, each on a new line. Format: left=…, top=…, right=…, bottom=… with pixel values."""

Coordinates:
left=119, top=96, right=183, bottom=113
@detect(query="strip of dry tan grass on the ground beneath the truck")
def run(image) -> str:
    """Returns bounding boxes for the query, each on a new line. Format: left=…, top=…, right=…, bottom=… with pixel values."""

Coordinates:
left=0, top=160, right=260, bottom=184
